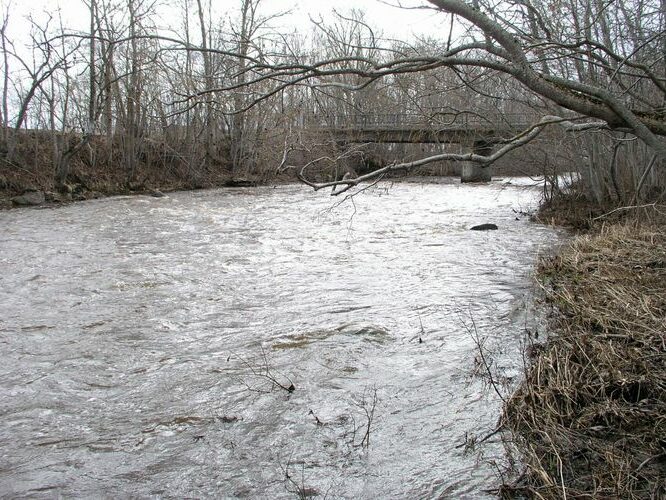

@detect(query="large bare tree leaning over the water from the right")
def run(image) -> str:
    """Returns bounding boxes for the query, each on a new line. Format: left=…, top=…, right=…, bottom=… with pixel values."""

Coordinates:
left=167, top=0, right=666, bottom=192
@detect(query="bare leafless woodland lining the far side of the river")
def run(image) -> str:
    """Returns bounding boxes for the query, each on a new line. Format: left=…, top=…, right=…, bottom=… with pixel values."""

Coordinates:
left=0, top=0, right=666, bottom=204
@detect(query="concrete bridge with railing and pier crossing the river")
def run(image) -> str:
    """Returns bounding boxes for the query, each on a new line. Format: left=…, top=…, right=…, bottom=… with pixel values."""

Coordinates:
left=308, top=113, right=530, bottom=182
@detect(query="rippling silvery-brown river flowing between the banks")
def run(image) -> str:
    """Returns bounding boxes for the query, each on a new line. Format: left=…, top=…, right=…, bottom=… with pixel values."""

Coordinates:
left=0, top=179, right=560, bottom=498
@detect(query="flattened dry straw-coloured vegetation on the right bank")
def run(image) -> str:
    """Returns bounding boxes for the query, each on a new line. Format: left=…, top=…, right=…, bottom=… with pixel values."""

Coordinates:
left=501, top=205, right=666, bottom=498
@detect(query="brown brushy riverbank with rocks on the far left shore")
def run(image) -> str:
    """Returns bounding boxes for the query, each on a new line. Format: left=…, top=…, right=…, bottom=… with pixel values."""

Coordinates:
left=0, top=130, right=295, bottom=209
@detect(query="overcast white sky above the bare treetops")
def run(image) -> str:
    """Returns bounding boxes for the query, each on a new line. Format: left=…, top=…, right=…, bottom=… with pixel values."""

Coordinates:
left=0, top=0, right=447, bottom=40
